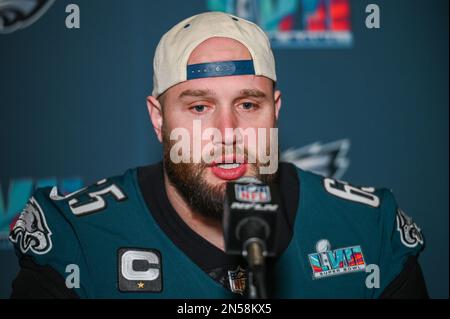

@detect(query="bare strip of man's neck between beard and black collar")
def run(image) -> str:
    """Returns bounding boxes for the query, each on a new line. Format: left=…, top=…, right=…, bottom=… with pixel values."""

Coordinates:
left=164, top=171, right=225, bottom=251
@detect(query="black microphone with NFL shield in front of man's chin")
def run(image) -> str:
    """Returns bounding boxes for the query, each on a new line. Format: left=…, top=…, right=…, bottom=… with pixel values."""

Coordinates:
left=223, top=177, right=281, bottom=299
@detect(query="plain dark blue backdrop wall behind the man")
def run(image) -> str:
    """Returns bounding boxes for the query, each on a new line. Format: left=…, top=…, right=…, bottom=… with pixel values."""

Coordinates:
left=0, top=0, right=449, bottom=298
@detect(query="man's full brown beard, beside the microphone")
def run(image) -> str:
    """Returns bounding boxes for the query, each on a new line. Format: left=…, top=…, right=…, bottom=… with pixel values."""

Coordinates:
left=162, top=128, right=278, bottom=221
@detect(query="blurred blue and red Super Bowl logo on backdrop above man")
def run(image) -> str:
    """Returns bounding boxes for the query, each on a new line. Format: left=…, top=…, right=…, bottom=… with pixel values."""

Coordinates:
left=207, top=0, right=353, bottom=48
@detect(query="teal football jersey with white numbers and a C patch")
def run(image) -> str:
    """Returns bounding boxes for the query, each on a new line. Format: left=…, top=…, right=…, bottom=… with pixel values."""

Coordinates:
left=10, top=164, right=423, bottom=298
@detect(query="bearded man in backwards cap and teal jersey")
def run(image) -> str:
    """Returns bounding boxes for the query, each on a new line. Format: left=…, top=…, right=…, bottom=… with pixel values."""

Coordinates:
left=10, top=12, right=427, bottom=299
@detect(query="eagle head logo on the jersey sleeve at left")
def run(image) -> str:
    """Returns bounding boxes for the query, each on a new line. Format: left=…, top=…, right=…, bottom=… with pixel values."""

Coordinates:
left=9, top=197, right=52, bottom=255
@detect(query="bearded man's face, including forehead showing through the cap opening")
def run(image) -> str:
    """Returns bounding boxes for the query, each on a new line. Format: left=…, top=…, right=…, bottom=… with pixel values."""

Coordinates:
left=151, top=38, right=281, bottom=219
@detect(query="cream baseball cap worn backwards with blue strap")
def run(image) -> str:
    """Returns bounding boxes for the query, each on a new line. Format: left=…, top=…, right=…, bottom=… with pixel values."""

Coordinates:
left=152, top=12, right=277, bottom=97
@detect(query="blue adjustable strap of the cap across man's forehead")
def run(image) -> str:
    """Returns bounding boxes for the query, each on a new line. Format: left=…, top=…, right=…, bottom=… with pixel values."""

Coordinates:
left=187, top=60, right=255, bottom=80
